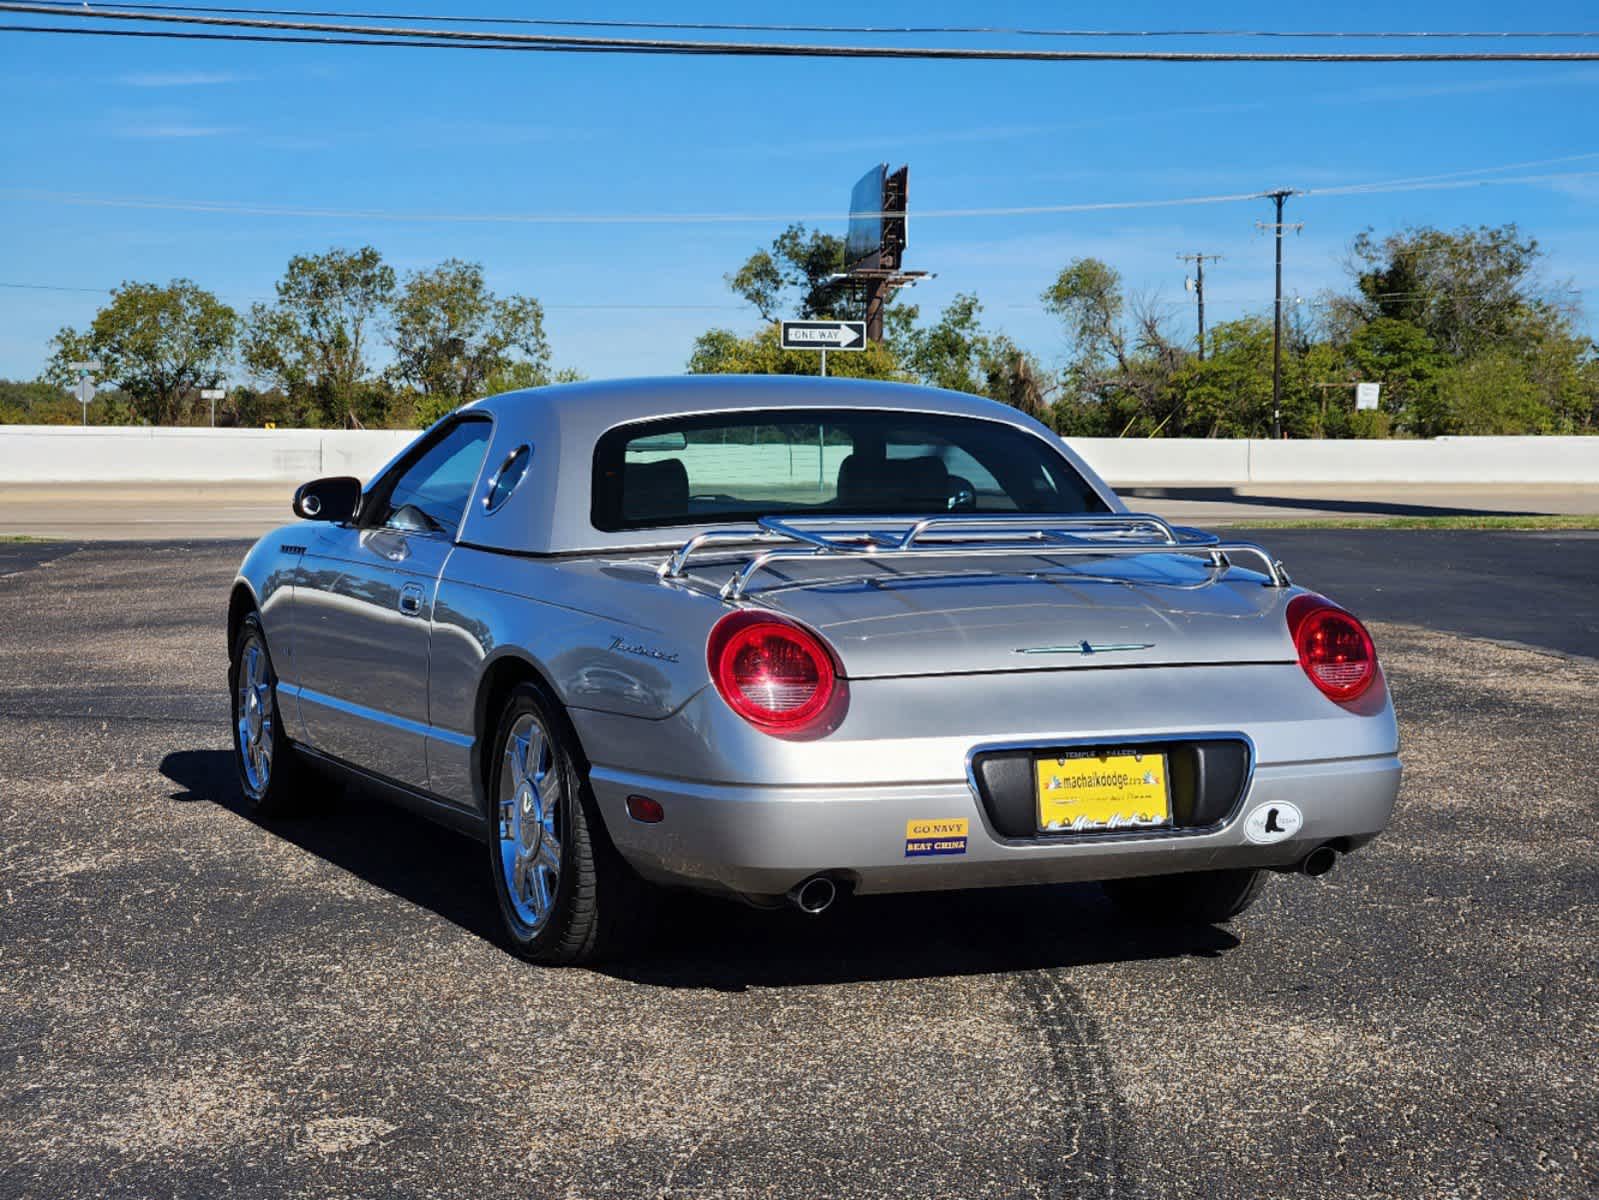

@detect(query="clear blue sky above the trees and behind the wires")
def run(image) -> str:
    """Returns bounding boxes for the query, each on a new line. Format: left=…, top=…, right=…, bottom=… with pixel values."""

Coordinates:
left=0, top=0, right=1599, bottom=378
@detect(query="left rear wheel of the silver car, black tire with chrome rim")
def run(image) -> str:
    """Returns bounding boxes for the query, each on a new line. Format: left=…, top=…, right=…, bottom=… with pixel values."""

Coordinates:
left=486, top=683, right=646, bottom=966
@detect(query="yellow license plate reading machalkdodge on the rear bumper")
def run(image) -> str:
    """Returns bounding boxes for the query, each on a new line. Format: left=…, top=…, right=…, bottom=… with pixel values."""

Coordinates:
left=1033, top=750, right=1172, bottom=834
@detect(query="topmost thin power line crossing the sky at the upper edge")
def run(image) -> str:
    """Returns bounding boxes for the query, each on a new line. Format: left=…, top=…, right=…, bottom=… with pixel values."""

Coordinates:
left=18, top=0, right=1599, bottom=42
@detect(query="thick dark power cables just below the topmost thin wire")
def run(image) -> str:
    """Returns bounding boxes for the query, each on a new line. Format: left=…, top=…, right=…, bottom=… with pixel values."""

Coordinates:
left=0, top=3, right=1599, bottom=62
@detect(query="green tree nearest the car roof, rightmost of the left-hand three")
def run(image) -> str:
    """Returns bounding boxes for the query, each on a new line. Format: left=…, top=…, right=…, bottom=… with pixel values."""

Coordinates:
left=390, top=259, right=550, bottom=421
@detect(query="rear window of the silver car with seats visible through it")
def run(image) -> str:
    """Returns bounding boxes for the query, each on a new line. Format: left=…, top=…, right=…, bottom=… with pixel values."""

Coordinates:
left=593, top=408, right=1105, bottom=533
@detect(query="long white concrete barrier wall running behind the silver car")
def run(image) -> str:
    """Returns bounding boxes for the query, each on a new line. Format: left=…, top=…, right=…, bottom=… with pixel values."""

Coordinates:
left=0, top=426, right=1599, bottom=485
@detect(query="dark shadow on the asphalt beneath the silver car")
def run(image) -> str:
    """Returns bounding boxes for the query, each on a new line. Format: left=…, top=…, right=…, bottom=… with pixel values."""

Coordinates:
left=160, top=750, right=1239, bottom=992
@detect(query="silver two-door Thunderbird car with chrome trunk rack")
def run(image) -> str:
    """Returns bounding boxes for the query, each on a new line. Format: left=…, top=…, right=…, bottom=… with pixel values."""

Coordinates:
left=227, top=376, right=1399, bottom=963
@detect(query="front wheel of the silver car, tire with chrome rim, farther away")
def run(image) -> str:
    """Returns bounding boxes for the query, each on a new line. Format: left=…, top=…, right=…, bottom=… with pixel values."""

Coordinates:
left=227, top=613, right=310, bottom=819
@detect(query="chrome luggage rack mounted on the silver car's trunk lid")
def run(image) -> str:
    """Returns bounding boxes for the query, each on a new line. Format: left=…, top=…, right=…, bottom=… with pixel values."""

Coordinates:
left=657, top=512, right=1290, bottom=600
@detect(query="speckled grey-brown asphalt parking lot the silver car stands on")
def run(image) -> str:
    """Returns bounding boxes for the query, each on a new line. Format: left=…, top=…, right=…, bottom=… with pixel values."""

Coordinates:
left=0, top=533, right=1599, bottom=1200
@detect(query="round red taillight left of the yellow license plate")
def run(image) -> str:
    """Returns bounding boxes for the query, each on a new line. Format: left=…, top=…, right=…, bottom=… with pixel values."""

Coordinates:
left=705, top=611, right=839, bottom=733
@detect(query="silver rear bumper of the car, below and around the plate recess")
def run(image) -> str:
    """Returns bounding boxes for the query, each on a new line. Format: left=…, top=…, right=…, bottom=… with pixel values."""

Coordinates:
left=592, top=754, right=1401, bottom=896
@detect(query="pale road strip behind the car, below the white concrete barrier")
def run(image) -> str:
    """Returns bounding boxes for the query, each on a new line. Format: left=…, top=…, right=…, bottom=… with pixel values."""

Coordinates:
left=0, top=480, right=1599, bottom=541
